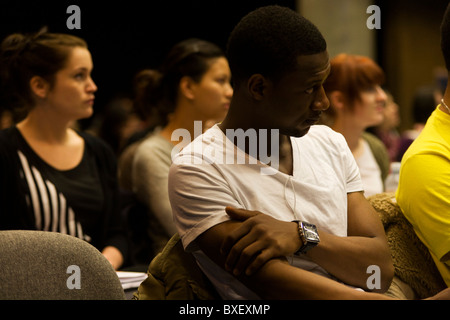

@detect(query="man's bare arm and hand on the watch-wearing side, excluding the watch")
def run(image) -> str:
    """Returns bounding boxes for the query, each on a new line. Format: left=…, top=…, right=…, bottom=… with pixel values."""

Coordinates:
left=218, top=193, right=393, bottom=292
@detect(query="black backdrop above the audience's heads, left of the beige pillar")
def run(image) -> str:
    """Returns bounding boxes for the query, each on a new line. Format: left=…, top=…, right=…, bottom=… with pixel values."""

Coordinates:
left=0, top=0, right=295, bottom=127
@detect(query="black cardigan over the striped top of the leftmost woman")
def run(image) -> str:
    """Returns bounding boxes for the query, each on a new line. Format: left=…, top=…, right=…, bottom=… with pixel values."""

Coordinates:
left=0, top=127, right=128, bottom=259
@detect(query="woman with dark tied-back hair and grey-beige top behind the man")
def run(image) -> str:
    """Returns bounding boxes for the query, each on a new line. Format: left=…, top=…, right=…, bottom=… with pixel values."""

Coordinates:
left=127, top=39, right=233, bottom=251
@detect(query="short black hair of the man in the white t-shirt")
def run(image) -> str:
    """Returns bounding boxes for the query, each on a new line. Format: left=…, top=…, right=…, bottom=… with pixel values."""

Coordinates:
left=227, top=5, right=327, bottom=84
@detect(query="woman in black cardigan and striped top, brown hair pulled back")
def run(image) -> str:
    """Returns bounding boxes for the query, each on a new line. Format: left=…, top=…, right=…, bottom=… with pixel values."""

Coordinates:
left=0, top=31, right=127, bottom=269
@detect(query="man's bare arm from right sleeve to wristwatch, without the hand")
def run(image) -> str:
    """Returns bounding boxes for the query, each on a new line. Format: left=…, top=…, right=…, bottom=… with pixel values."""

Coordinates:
left=308, top=192, right=394, bottom=292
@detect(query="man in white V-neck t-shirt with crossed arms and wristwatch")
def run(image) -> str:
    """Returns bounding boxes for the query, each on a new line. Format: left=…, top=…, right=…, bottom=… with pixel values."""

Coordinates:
left=169, top=6, right=450, bottom=299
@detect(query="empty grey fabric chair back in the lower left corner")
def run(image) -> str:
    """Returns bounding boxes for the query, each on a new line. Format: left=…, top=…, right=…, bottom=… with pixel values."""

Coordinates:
left=0, top=230, right=125, bottom=300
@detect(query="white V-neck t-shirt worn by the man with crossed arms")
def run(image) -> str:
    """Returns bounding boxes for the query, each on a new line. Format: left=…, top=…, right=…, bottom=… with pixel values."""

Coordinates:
left=169, top=125, right=363, bottom=299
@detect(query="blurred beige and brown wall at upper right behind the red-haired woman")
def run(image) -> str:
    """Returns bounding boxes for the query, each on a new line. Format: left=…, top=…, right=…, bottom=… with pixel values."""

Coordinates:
left=297, top=0, right=448, bottom=129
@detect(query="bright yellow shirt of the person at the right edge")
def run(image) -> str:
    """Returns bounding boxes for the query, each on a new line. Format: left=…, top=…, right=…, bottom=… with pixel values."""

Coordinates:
left=396, top=106, right=450, bottom=286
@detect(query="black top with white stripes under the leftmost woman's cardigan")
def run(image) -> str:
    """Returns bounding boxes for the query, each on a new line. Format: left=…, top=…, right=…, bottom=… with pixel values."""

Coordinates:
left=12, top=130, right=103, bottom=241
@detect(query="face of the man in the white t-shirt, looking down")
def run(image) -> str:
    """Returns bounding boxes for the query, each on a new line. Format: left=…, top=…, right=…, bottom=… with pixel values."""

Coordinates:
left=266, top=51, right=330, bottom=137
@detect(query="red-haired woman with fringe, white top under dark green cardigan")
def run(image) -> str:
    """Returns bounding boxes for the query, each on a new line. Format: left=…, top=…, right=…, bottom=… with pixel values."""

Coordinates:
left=323, top=54, right=389, bottom=197
